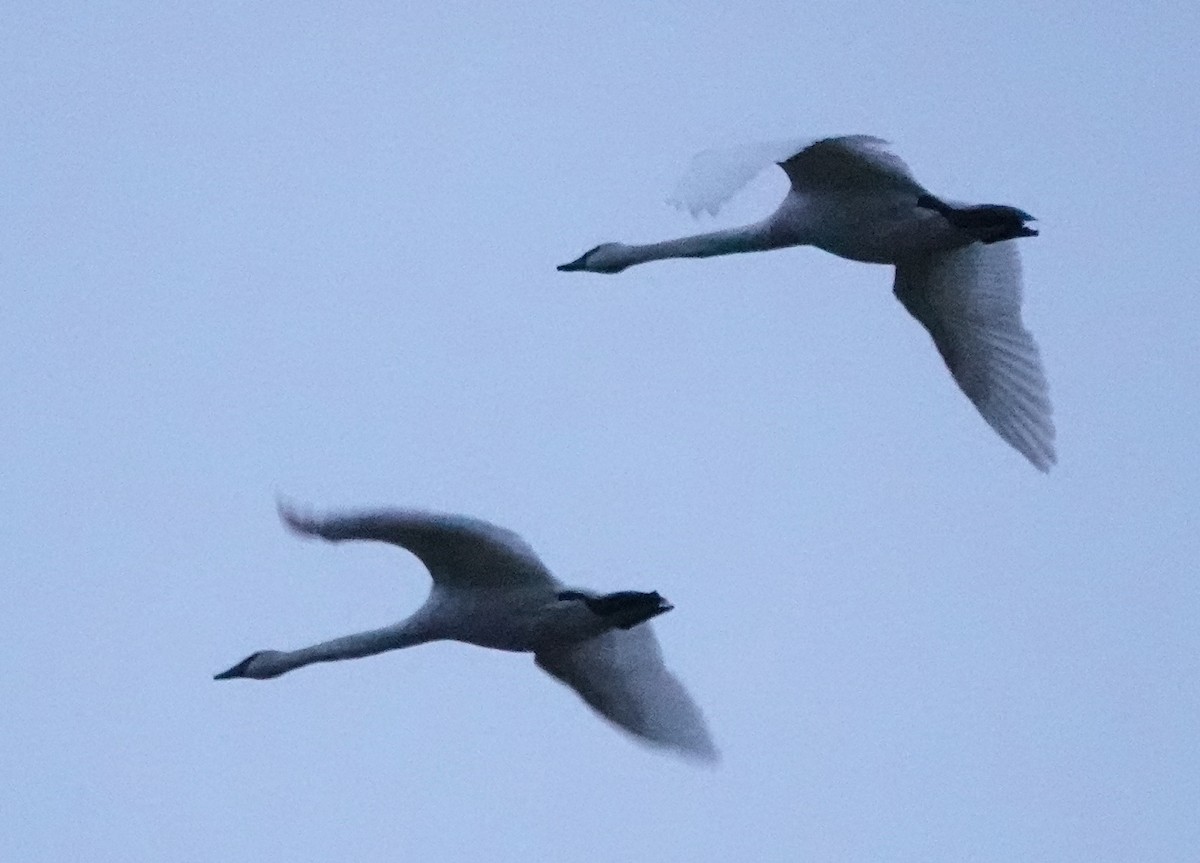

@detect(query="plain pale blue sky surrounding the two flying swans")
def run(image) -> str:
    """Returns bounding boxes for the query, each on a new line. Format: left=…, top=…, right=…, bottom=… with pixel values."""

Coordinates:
left=0, top=0, right=1200, bottom=863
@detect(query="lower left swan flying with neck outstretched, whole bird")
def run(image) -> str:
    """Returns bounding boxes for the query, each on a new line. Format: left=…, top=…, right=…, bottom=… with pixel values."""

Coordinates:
left=215, top=503, right=716, bottom=760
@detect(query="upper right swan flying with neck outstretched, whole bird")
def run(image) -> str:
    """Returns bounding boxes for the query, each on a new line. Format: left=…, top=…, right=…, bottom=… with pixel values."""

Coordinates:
left=558, top=134, right=1056, bottom=471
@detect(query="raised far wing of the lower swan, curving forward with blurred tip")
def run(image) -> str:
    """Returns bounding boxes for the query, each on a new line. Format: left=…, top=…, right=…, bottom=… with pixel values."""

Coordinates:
left=280, top=502, right=558, bottom=587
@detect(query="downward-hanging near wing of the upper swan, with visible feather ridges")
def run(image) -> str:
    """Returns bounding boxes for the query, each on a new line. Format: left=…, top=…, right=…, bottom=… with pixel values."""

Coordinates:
left=895, top=241, right=1056, bottom=471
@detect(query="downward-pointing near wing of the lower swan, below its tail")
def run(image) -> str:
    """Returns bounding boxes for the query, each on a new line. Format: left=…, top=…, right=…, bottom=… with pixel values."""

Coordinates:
left=535, top=623, right=718, bottom=761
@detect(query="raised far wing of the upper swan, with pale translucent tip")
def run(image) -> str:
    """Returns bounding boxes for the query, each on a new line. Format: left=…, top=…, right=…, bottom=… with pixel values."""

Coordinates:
left=667, top=134, right=924, bottom=216
